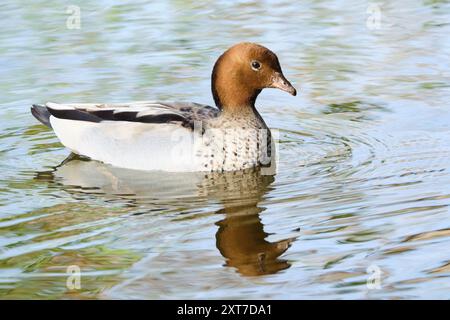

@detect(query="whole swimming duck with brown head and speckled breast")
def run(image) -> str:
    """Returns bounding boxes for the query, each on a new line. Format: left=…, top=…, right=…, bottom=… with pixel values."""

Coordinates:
left=31, top=42, right=297, bottom=172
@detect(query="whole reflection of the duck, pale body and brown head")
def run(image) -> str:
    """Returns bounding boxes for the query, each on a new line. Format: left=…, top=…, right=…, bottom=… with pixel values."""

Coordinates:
left=36, top=155, right=295, bottom=276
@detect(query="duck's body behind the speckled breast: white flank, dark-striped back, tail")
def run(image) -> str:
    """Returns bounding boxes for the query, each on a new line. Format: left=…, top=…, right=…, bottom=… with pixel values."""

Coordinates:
left=32, top=102, right=219, bottom=172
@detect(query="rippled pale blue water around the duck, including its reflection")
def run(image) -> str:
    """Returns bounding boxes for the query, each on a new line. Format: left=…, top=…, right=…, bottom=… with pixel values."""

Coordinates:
left=0, top=0, right=450, bottom=299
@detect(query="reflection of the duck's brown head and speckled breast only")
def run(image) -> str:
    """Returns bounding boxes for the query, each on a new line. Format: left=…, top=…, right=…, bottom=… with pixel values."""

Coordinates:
left=200, top=170, right=295, bottom=276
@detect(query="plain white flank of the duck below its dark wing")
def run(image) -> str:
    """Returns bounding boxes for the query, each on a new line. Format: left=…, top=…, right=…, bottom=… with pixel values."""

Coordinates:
left=50, top=117, right=204, bottom=172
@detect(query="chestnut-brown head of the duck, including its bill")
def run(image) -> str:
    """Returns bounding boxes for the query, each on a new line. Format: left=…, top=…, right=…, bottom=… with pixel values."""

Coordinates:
left=211, top=42, right=297, bottom=110
